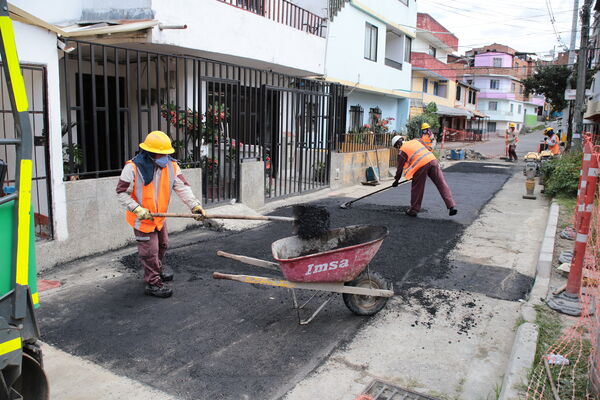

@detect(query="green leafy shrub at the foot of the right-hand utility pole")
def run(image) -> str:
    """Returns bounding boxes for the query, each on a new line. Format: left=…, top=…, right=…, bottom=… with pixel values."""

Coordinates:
left=542, top=152, right=583, bottom=197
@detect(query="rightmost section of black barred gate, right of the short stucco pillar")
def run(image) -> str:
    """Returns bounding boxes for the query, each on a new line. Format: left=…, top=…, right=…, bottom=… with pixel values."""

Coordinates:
left=263, top=86, right=342, bottom=198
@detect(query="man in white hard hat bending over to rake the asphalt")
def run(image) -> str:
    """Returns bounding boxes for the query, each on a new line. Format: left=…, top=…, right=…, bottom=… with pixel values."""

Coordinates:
left=392, top=135, right=458, bottom=217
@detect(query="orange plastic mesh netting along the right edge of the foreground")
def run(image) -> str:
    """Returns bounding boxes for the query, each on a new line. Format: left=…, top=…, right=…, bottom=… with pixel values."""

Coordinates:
left=525, top=145, right=600, bottom=400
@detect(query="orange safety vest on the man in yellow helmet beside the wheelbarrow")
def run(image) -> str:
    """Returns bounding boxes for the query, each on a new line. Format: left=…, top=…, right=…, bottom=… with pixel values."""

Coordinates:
left=125, top=160, right=177, bottom=233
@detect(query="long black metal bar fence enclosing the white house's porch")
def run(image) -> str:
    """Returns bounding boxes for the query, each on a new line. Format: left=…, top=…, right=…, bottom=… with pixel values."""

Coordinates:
left=61, top=40, right=341, bottom=204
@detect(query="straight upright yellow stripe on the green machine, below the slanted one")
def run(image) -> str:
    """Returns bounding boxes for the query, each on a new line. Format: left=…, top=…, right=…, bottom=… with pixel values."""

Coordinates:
left=15, top=160, right=32, bottom=286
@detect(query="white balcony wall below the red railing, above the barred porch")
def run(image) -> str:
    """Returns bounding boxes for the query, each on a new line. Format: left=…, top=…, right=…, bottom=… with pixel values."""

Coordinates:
left=152, top=0, right=325, bottom=74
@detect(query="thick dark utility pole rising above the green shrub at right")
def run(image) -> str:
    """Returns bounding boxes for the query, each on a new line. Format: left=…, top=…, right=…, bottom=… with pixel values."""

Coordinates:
left=571, top=0, right=592, bottom=150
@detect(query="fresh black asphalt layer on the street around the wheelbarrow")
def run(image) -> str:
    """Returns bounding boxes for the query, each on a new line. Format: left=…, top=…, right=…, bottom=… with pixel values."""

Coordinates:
left=39, top=161, right=528, bottom=399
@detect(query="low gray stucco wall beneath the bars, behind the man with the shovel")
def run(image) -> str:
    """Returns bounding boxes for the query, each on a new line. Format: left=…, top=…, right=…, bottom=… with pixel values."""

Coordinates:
left=36, top=168, right=202, bottom=271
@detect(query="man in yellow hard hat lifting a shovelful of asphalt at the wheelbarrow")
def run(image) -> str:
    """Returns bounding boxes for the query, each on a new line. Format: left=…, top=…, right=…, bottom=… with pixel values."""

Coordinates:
left=117, top=131, right=206, bottom=297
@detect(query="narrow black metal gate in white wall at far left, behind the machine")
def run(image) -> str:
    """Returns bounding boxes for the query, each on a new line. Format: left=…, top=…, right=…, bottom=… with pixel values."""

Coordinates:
left=0, top=64, right=53, bottom=239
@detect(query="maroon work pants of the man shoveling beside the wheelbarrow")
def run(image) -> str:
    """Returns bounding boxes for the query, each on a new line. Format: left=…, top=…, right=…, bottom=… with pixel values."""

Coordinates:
left=133, top=224, right=169, bottom=286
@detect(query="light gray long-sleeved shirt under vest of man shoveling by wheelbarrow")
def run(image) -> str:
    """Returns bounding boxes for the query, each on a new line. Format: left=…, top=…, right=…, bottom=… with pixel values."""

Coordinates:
left=117, top=163, right=202, bottom=211
